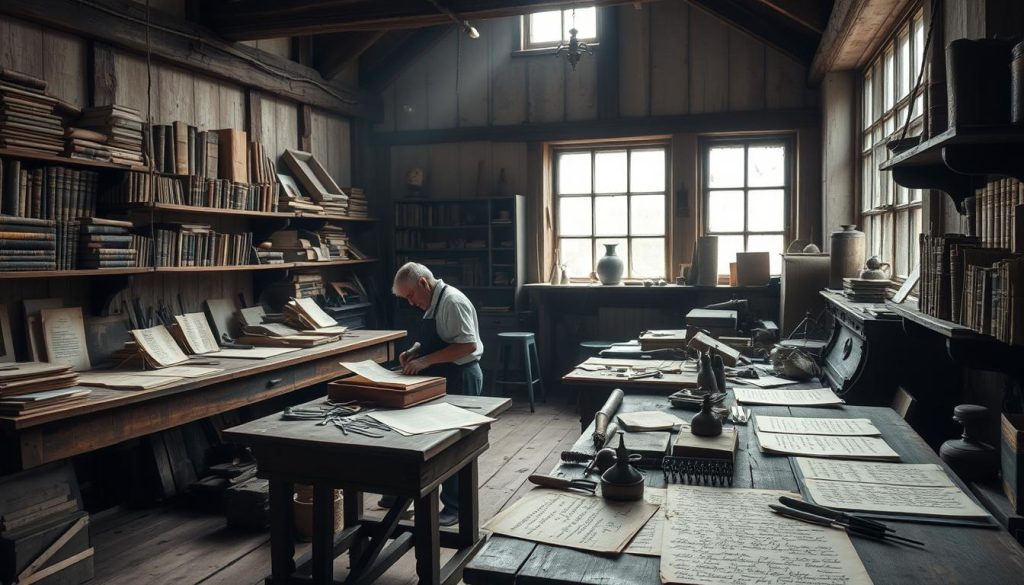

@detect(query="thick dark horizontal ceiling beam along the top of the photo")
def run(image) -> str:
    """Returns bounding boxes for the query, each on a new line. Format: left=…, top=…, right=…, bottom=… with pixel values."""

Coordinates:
left=203, top=0, right=653, bottom=40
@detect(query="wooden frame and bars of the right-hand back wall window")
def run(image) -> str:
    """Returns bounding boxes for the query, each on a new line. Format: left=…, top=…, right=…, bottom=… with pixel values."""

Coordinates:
left=699, top=133, right=796, bottom=282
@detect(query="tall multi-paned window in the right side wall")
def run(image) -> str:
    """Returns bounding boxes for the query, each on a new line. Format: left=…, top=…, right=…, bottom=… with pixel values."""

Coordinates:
left=860, top=8, right=925, bottom=277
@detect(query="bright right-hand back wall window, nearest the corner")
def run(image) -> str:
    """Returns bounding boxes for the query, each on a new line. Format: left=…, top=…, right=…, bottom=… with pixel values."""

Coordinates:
left=702, top=137, right=791, bottom=276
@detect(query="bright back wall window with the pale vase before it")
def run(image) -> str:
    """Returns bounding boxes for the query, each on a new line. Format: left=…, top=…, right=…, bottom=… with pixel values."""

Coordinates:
left=554, top=144, right=669, bottom=279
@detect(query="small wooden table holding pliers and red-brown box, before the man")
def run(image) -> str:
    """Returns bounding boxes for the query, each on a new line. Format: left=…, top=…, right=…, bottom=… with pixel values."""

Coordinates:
left=224, top=395, right=511, bottom=585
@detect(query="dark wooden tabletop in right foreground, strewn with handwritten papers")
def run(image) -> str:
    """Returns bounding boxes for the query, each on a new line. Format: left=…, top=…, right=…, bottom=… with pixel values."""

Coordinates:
left=463, top=395, right=1024, bottom=585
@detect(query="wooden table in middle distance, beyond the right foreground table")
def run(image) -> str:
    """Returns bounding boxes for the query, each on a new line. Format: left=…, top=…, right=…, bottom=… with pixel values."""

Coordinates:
left=562, top=358, right=697, bottom=429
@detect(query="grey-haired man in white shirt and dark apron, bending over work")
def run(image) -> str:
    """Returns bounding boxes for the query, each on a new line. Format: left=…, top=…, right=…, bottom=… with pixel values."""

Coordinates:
left=385, top=262, right=483, bottom=526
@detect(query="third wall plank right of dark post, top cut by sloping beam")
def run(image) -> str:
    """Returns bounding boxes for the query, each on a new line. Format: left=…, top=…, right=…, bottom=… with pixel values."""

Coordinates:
left=689, top=7, right=729, bottom=114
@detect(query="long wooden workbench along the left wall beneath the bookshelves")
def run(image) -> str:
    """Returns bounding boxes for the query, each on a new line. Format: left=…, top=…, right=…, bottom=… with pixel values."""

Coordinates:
left=0, top=330, right=406, bottom=472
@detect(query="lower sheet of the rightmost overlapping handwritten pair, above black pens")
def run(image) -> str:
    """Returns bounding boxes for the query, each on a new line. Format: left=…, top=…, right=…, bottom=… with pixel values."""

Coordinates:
left=804, top=479, right=988, bottom=518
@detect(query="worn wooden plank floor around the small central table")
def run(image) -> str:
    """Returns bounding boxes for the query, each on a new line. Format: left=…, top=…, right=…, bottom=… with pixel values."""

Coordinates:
left=91, top=398, right=580, bottom=585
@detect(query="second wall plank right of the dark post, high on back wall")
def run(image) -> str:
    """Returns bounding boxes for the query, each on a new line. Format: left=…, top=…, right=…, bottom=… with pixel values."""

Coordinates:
left=650, top=2, right=690, bottom=116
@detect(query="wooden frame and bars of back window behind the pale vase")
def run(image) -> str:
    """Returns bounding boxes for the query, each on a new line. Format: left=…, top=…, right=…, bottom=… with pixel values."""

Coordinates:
left=551, top=139, right=672, bottom=282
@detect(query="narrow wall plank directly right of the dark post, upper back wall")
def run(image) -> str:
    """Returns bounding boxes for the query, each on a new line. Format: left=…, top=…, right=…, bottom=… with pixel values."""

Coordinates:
left=618, top=4, right=651, bottom=117
